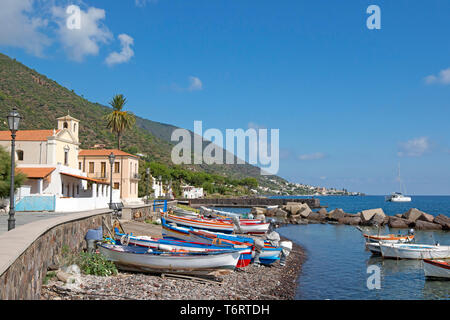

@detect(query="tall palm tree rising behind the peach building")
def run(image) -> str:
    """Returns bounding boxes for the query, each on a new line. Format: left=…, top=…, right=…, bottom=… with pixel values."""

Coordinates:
left=105, top=94, right=136, bottom=150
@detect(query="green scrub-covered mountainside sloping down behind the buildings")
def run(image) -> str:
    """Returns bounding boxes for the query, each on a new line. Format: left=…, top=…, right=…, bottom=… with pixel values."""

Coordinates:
left=0, top=54, right=284, bottom=186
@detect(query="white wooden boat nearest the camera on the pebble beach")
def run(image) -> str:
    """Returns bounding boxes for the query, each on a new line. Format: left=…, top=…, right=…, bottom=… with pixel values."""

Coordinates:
left=98, top=243, right=240, bottom=275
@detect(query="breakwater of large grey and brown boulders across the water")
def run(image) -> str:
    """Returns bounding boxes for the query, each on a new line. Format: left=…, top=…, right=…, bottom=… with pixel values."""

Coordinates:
left=252, top=202, right=450, bottom=230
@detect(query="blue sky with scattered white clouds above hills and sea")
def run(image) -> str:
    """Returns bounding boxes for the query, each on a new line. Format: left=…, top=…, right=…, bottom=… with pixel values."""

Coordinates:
left=0, top=0, right=450, bottom=194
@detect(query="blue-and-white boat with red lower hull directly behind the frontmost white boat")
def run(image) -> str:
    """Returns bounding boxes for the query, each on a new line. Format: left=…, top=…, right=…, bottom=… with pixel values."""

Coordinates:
left=114, top=230, right=252, bottom=268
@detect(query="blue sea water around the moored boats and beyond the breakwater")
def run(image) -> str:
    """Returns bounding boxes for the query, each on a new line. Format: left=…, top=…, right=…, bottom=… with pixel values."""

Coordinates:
left=223, top=196, right=450, bottom=300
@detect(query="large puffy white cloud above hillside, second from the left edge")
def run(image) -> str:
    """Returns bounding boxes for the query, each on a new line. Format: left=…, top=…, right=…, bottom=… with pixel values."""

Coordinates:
left=52, top=6, right=113, bottom=62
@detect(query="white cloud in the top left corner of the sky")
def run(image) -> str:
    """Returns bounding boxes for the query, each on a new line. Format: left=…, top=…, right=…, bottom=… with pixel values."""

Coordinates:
left=0, top=0, right=51, bottom=56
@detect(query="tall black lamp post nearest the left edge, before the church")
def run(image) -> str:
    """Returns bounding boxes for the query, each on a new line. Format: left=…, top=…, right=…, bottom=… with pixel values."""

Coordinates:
left=6, top=107, right=22, bottom=231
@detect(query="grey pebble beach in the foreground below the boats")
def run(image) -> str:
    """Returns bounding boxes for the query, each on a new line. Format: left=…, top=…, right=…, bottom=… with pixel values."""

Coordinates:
left=41, top=221, right=305, bottom=300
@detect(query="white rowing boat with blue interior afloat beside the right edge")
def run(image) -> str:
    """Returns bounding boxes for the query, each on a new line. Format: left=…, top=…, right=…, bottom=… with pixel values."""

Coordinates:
left=380, top=242, right=450, bottom=259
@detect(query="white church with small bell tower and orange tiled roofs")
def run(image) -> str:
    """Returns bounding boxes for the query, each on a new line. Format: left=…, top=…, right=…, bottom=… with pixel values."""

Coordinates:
left=0, top=115, right=120, bottom=212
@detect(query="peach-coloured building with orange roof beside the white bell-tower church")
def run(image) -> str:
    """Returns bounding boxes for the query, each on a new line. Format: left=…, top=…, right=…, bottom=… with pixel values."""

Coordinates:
left=78, top=149, right=140, bottom=203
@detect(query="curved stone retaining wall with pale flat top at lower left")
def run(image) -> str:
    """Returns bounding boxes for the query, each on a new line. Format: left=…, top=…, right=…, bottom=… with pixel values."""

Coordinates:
left=0, top=209, right=111, bottom=300
